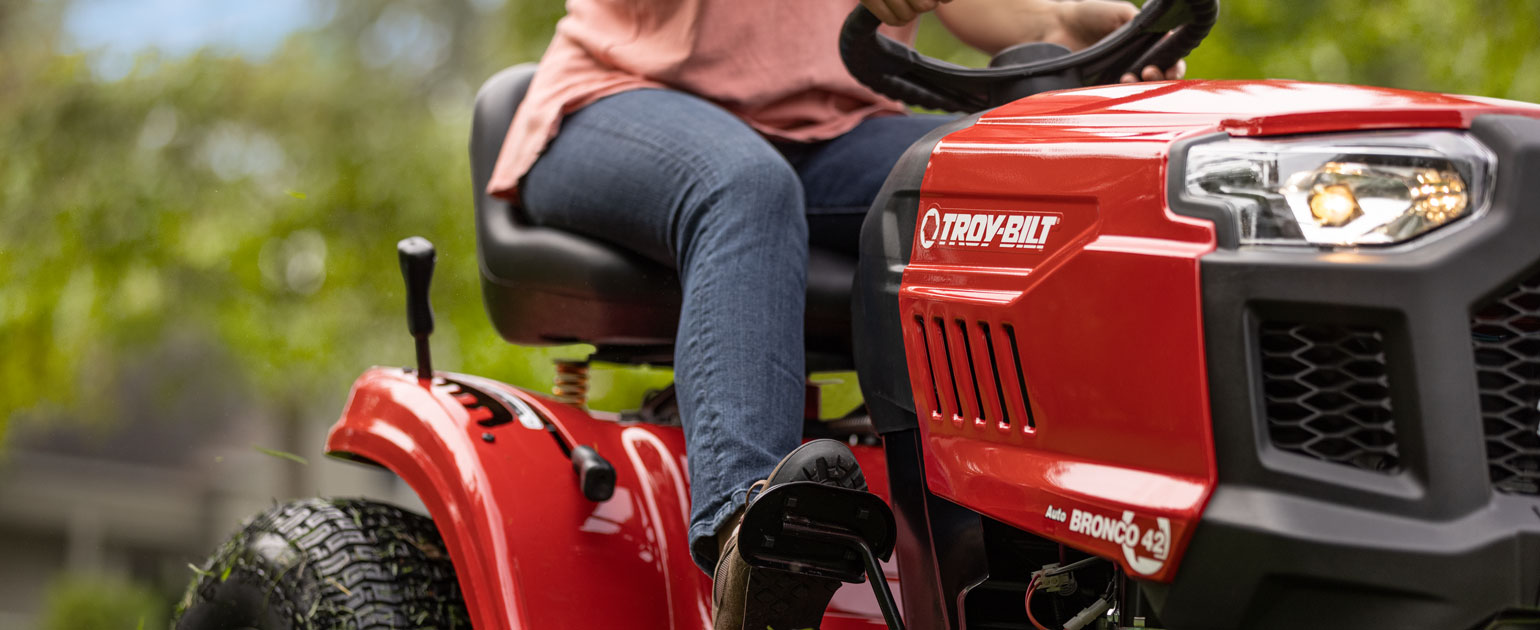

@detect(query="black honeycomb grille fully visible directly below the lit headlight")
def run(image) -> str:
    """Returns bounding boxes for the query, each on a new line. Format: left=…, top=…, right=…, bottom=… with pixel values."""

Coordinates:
left=1260, top=322, right=1400, bottom=471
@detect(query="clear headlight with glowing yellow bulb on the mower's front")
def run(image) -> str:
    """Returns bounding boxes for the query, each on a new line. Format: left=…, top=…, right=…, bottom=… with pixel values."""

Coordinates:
left=1186, top=131, right=1494, bottom=246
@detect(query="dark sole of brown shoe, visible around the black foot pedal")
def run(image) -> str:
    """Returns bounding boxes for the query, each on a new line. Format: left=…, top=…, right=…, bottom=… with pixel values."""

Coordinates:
left=744, top=439, right=867, bottom=630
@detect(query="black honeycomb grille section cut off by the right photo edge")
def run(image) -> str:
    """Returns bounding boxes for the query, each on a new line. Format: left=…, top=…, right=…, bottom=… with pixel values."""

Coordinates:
left=1471, top=274, right=1540, bottom=494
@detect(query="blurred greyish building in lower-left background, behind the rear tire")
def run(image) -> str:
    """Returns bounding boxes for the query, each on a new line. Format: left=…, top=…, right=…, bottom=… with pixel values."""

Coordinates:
left=0, top=383, right=424, bottom=630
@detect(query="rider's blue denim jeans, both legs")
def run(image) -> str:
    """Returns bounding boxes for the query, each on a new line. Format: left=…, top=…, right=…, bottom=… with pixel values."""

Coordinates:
left=521, top=89, right=949, bottom=573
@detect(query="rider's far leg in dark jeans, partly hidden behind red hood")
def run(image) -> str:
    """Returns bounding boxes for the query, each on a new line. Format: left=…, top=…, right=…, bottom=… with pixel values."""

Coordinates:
left=782, top=114, right=956, bottom=256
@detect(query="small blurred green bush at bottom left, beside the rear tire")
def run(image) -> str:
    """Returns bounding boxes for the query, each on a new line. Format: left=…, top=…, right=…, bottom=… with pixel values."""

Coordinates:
left=42, top=576, right=168, bottom=630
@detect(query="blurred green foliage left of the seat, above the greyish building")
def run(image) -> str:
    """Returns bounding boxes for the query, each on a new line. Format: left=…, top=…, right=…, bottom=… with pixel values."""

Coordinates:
left=0, top=3, right=570, bottom=437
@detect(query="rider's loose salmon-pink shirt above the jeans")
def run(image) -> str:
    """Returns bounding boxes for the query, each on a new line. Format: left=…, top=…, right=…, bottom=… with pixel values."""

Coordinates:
left=487, top=0, right=915, bottom=197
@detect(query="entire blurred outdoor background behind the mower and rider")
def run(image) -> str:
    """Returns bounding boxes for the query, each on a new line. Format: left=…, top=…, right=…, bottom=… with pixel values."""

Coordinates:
left=0, top=0, right=1540, bottom=630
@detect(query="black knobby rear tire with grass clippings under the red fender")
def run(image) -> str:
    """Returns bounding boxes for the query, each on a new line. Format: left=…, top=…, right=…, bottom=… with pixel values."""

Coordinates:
left=174, top=499, right=471, bottom=630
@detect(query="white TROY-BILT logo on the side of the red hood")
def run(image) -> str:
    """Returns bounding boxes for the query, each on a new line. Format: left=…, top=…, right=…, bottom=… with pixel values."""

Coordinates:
left=919, top=206, right=1061, bottom=251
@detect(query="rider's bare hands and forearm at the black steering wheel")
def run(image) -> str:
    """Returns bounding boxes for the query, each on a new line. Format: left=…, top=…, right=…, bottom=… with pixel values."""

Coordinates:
left=861, top=0, right=1187, bottom=83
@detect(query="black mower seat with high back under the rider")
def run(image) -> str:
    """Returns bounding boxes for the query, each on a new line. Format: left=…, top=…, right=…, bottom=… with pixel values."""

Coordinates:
left=471, top=63, right=855, bottom=363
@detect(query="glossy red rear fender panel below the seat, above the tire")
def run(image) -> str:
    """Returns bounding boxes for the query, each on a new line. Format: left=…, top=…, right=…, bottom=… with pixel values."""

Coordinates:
left=326, top=368, right=896, bottom=630
